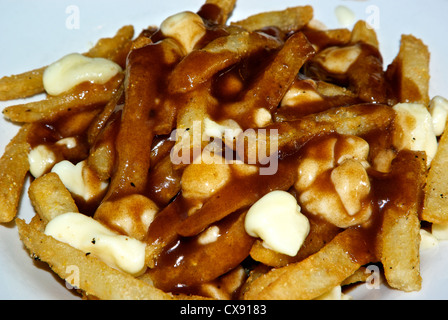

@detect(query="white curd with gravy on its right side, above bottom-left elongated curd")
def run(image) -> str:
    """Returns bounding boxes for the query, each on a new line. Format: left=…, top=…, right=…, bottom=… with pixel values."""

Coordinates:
left=51, top=160, right=108, bottom=201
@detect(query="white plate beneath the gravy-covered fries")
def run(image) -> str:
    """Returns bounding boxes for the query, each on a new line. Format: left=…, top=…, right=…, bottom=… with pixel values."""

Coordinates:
left=0, top=0, right=448, bottom=299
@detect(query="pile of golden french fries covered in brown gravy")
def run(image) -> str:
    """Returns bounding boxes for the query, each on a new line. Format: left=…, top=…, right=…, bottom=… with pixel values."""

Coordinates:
left=0, top=0, right=448, bottom=299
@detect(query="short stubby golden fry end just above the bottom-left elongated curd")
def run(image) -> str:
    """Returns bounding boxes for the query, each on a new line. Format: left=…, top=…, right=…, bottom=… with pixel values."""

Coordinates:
left=28, top=172, right=78, bottom=223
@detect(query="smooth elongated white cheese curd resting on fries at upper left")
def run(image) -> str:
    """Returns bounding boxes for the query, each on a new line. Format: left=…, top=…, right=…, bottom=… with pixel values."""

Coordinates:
left=43, top=53, right=122, bottom=96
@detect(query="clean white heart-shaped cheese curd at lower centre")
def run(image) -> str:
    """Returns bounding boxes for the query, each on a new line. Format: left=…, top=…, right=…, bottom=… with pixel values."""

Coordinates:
left=245, top=191, right=310, bottom=256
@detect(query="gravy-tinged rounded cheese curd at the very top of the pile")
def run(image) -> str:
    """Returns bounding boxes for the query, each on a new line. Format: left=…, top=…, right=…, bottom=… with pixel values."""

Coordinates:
left=160, top=11, right=206, bottom=54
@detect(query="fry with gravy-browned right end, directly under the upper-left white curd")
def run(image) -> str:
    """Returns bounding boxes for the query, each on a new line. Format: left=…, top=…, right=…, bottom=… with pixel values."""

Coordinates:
left=3, top=73, right=123, bottom=122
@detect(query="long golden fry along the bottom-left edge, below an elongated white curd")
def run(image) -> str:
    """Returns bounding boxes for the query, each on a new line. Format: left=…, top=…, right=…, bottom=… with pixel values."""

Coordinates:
left=16, top=219, right=174, bottom=300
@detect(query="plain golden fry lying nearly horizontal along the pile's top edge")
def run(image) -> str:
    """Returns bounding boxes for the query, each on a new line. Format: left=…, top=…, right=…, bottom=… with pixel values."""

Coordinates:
left=231, top=6, right=313, bottom=33
